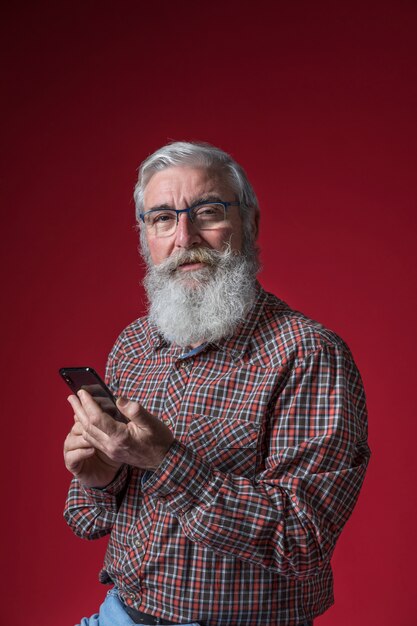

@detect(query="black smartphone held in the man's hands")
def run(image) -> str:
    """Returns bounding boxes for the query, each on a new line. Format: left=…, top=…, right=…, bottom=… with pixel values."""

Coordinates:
left=59, top=367, right=129, bottom=424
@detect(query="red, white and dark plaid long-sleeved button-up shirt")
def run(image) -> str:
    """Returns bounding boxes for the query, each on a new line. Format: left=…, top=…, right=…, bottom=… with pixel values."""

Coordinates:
left=65, top=286, right=369, bottom=626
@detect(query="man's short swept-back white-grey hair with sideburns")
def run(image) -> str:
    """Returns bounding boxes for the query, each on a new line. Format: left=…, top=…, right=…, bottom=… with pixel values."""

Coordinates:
left=133, top=141, right=259, bottom=262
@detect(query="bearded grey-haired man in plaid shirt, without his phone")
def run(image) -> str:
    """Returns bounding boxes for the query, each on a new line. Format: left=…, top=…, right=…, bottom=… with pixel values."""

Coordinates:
left=64, top=142, right=369, bottom=626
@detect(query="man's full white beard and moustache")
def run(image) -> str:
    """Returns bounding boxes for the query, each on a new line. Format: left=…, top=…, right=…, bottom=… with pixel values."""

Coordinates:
left=144, top=247, right=258, bottom=347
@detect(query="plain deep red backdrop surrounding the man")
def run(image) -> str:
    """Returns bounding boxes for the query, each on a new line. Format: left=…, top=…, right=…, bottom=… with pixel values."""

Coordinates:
left=0, top=0, right=417, bottom=626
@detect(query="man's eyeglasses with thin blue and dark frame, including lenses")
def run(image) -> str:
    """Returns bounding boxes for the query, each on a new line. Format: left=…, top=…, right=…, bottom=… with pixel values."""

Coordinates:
left=139, top=201, right=240, bottom=237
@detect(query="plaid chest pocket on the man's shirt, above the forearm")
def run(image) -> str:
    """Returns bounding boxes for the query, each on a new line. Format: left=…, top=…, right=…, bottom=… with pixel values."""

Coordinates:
left=186, top=415, right=260, bottom=478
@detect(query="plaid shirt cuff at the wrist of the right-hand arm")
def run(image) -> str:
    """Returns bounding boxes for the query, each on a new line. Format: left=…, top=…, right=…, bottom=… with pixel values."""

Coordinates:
left=142, top=440, right=220, bottom=515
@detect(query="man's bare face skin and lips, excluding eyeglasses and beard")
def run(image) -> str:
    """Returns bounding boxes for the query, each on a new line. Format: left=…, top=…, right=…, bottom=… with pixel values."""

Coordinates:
left=144, top=167, right=242, bottom=272
